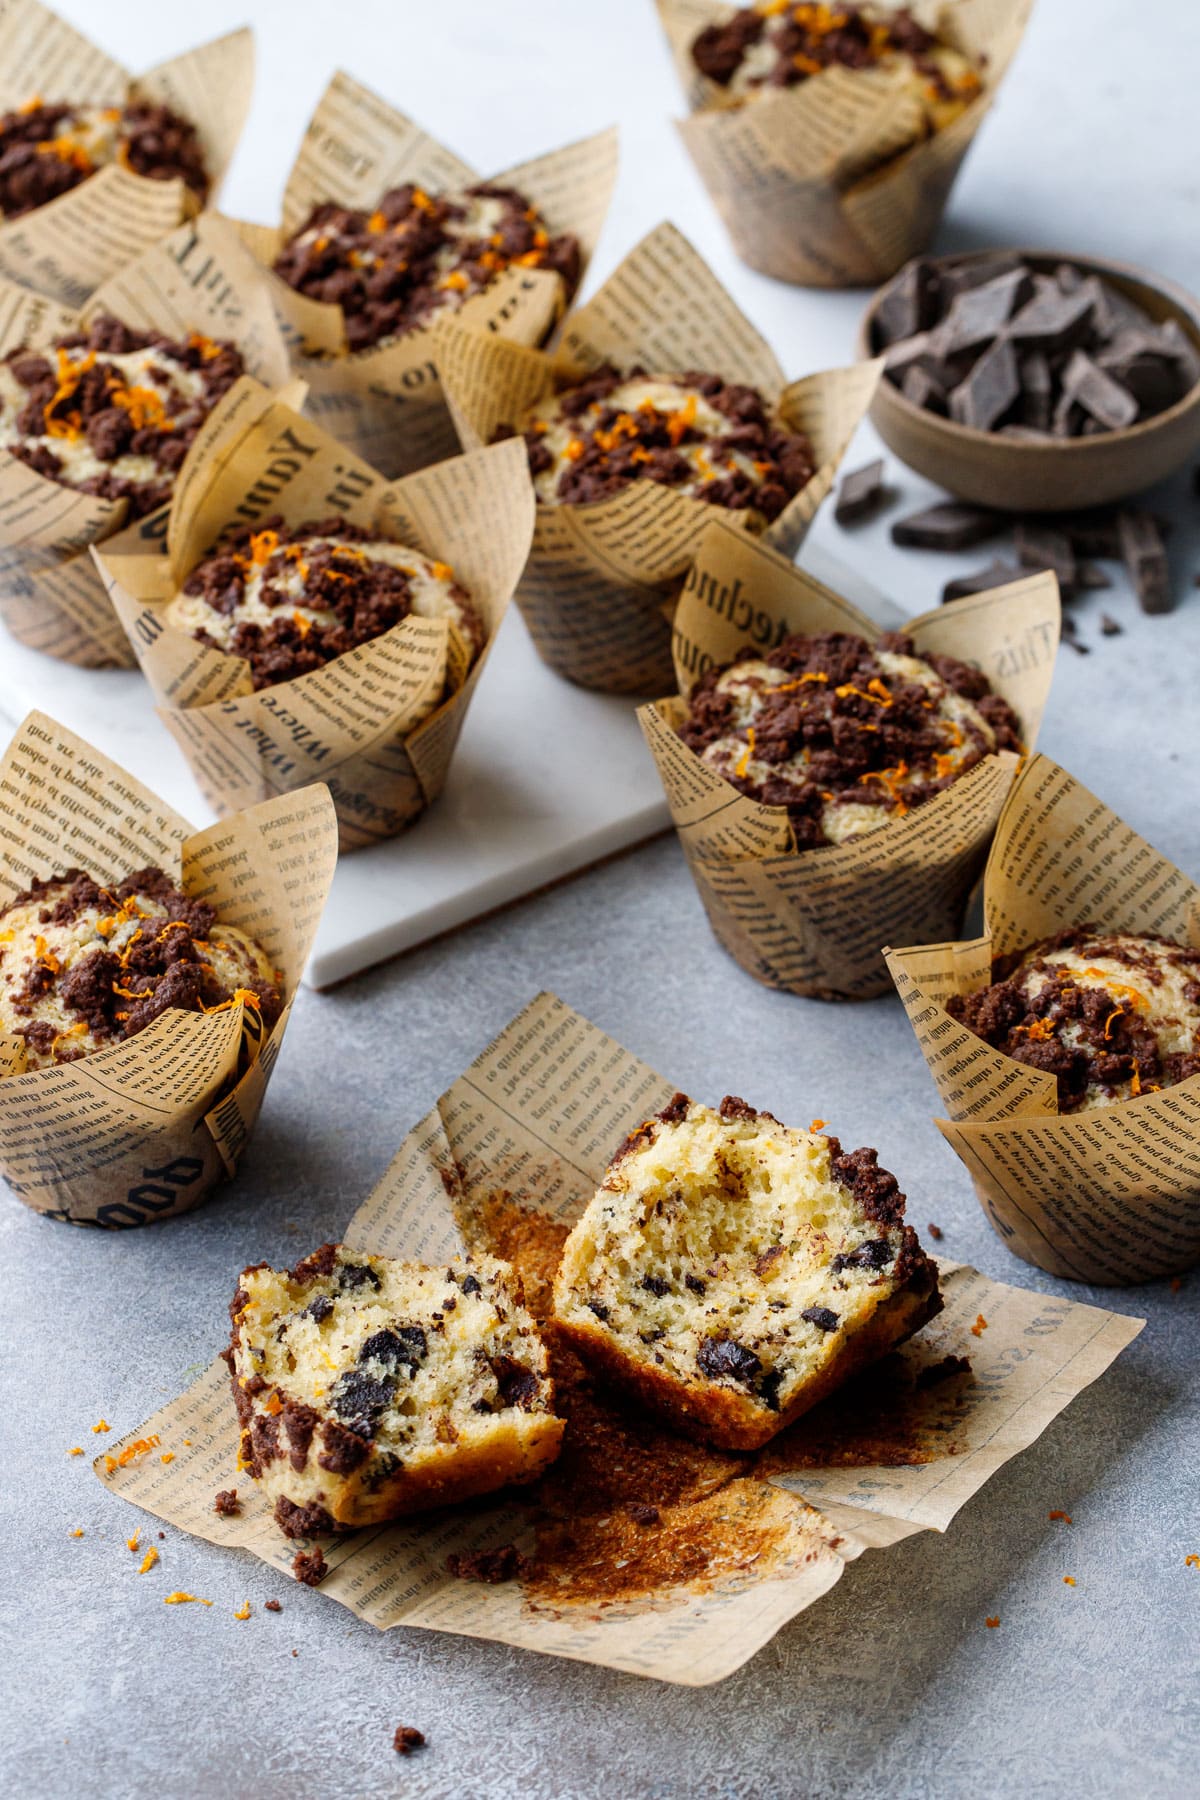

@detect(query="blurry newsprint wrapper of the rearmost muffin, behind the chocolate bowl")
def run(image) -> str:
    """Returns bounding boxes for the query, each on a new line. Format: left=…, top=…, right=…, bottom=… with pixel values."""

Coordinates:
left=658, top=0, right=1033, bottom=288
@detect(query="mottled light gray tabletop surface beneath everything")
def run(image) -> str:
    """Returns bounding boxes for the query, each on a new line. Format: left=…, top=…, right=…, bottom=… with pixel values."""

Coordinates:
left=0, top=0, right=1200, bottom=1800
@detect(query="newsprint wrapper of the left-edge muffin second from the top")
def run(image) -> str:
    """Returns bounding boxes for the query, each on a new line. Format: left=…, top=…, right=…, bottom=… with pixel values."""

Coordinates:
left=0, top=210, right=290, bottom=668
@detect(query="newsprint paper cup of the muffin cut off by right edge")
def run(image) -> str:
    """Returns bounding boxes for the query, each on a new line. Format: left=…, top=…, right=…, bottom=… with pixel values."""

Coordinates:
left=883, top=756, right=1200, bottom=1287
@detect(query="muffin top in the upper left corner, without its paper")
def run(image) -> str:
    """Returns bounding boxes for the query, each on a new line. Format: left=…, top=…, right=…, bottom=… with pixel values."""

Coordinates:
left=0, top=99, right=209, bottom=220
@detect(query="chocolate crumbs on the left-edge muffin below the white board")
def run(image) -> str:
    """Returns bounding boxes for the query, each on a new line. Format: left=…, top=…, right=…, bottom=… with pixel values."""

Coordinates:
left=0, top=868, right=282, bottom=1062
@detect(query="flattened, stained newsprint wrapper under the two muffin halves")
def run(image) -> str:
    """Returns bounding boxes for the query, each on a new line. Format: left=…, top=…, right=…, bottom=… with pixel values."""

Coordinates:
left=94, top=994, right=1142, bottom=1687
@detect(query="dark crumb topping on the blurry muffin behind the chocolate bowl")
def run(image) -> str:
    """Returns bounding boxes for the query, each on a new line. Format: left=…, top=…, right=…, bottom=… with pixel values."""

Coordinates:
left=691, top=4, right=959, bottom=99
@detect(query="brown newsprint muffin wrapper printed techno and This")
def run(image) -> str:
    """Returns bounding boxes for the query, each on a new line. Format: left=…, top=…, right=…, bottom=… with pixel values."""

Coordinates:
left=637, top=524, right=1060, bottom=999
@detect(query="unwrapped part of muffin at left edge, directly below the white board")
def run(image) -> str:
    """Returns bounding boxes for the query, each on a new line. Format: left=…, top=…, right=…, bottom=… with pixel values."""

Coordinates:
left=0, top=868, right=282, bottom=1069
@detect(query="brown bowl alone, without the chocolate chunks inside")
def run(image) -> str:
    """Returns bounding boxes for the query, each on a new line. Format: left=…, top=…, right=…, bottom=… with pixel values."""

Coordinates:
left=858, top=250, right=1200, bottom=513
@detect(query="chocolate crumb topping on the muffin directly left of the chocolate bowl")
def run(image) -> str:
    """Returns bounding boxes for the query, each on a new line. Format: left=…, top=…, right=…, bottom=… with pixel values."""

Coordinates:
left=524, top=364, right=817, bottom=520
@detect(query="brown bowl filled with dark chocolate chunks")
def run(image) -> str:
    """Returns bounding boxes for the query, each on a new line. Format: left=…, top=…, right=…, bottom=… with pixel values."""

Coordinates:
left=858, top=250, right=1200, bottom=513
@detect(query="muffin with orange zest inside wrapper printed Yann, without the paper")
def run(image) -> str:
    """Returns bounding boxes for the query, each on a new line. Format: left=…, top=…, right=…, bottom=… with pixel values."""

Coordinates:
left=167, top=517, right=486, bottom=688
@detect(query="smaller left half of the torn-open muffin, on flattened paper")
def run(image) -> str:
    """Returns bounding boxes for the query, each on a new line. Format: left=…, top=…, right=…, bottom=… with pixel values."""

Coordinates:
left=225, top=1244, right=563, bottom=1537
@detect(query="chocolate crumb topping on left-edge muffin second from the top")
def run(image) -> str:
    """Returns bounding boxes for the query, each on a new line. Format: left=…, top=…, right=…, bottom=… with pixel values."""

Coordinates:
left=4, top=313, right=245, bottom=518
